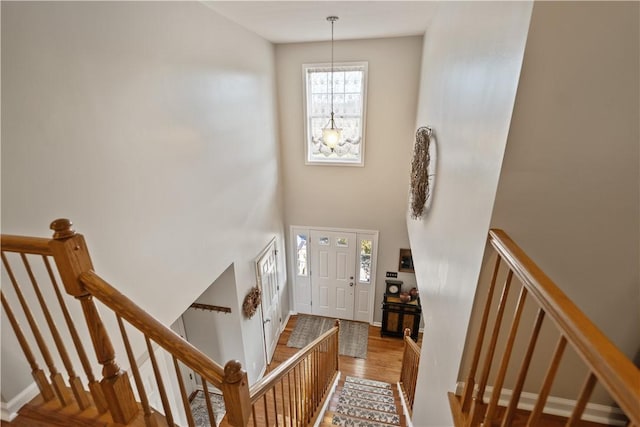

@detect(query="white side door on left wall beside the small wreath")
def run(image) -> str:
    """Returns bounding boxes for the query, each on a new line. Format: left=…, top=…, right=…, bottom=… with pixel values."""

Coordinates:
left=256, top=239, right=280, bottom=363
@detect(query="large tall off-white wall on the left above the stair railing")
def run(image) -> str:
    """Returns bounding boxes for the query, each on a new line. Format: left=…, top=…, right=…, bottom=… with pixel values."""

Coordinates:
left=2, top=2, right=286, bottom=399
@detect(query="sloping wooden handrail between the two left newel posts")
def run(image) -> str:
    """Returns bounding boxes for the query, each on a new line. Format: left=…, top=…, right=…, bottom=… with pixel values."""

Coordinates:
left=80, top=271, right=224, bottom=388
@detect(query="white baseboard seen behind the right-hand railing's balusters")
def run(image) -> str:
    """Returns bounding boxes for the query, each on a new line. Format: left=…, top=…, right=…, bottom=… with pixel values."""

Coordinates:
left=456, top=382, right=626, bottom=426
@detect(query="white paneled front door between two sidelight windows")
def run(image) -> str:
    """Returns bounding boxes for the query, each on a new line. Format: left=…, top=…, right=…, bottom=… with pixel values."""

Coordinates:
left=309, top=230, right=357, bottom=320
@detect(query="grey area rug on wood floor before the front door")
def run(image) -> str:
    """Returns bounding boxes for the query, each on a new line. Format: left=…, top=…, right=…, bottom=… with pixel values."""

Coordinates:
left=287, top=314, right=369, bottom=359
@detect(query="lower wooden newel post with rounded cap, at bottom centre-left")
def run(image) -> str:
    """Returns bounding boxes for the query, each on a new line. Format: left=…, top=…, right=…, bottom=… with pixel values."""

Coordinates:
left=222, top=360, right=251, bottom=427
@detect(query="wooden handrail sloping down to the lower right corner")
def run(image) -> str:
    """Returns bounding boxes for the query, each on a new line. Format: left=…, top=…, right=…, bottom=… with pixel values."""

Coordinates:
left=489, top=229, right=640, bottom=425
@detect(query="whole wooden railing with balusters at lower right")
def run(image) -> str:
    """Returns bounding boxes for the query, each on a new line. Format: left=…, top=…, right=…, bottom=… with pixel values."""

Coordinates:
left=449, top=230, right=640, bottom=427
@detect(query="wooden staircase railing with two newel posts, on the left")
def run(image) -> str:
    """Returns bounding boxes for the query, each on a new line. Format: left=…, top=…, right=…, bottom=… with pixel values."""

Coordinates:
left=1, top=219, right=339, bottom=427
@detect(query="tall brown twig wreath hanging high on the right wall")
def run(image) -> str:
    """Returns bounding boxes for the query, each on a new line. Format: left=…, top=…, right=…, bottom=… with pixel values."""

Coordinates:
left=411, top=126, right=433, bottom=219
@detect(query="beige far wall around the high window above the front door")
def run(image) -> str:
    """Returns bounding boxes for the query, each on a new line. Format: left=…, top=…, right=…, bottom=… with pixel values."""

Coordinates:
left=276, top=36, right=422, bottom=322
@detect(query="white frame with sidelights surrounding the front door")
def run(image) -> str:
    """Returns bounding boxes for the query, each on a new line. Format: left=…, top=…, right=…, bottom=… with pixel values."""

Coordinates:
left=287, top=225, right=380, bottom=324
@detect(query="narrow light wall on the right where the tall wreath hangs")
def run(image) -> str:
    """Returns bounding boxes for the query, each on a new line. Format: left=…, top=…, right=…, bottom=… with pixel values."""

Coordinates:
left=407, top=2, right=531, bottom=427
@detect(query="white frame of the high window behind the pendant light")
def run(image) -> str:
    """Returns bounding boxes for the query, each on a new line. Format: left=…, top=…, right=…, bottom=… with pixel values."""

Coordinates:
left=302, top=61, right=369, bottom=167
